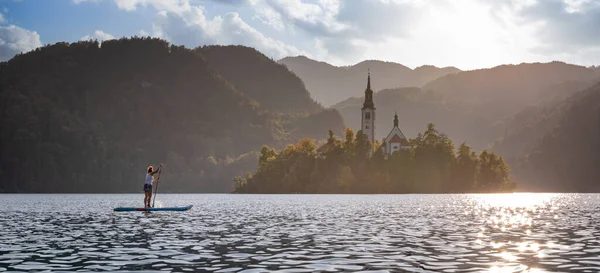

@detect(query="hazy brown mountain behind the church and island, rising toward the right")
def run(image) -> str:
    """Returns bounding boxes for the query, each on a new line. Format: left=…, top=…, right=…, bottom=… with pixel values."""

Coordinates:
left=332, top=62, right=597, bottom=151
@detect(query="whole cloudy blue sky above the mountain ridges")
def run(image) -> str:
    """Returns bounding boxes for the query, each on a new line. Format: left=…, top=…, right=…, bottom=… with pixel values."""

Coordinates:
left=0, top=0, right=600, bottom=70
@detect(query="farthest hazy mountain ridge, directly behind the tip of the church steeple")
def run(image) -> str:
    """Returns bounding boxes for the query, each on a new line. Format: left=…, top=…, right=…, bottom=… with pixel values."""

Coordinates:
left=279, top=56, right=460, bottom=106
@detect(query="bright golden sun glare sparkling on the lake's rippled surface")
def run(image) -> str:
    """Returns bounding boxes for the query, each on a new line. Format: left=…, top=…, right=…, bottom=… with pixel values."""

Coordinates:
left=469, top=193, right=560, bottom=272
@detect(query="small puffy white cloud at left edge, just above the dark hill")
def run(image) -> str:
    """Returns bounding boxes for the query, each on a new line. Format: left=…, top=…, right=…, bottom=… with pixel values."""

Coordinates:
left=0, top=25, right=42, bottom=61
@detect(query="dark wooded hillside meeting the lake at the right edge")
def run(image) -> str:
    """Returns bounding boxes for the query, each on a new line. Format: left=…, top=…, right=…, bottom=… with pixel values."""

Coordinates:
left=515, top=83, right=600, bottom=192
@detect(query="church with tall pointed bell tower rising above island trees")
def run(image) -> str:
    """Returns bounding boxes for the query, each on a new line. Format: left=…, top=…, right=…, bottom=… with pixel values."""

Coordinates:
left=360, top=71, right=410, bottom=158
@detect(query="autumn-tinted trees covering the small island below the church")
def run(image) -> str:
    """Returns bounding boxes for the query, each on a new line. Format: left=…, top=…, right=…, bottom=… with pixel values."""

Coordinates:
left=234, top=123, right=516, bottom=193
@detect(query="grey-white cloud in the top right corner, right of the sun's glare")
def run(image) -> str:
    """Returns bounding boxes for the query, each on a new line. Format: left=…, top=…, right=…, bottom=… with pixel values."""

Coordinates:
left=492, top=0, right=600, bottom=64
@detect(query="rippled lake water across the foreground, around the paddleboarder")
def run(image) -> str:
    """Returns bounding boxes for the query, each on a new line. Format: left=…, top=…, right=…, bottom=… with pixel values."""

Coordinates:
left=0, top=193, right=600, bottom=272
